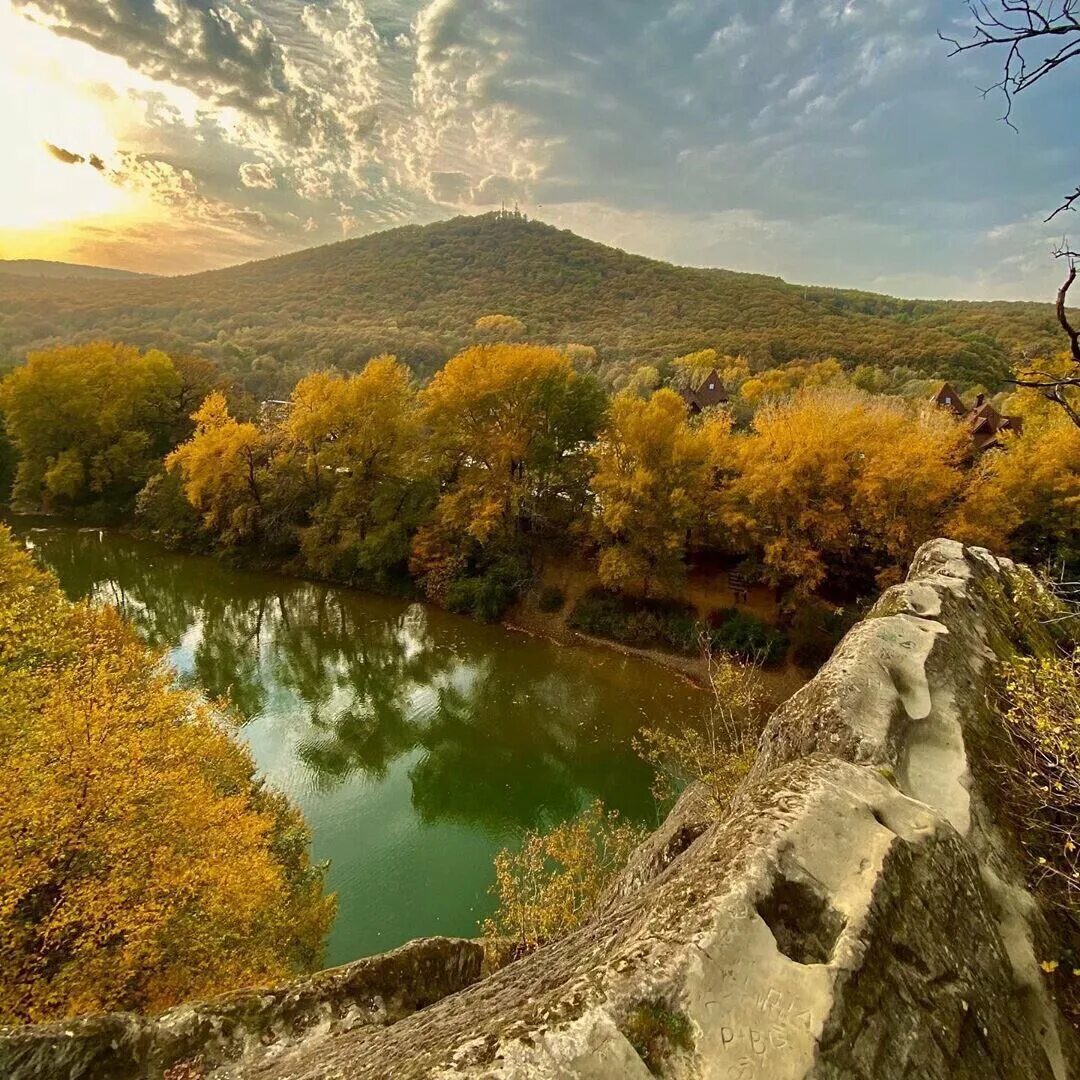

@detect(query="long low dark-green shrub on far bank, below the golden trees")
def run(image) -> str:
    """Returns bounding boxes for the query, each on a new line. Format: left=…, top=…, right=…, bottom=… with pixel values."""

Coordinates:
left=567, top=588, right=700, bottom=654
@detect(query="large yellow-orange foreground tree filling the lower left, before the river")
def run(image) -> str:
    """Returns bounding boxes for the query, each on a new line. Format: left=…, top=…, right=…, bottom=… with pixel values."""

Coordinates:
left=0, top=529, right=334, bottom=1023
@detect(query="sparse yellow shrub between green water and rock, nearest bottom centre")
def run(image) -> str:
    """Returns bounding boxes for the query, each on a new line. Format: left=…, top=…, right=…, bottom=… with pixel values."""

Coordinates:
left=481, top=801, right=647, bottom=953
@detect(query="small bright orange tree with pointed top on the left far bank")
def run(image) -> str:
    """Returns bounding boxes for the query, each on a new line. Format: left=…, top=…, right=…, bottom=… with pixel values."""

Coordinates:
left=165, top=391, right=270, bottom=544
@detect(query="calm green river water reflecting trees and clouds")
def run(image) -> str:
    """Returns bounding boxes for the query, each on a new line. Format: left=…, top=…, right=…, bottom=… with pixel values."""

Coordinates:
left=15, top=523, right=703, bottom=964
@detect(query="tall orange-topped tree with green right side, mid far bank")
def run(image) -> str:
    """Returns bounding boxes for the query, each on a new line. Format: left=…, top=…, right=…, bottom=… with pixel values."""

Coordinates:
left=413, top=345, right=605, bottom=592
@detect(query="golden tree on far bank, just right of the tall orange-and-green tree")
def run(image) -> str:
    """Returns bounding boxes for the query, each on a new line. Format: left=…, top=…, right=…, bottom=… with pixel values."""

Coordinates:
left=590, top=390, right=730, bottom=594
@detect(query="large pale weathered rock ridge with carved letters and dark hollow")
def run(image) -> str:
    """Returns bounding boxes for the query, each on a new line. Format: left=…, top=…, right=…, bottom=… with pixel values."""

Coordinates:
left=4, top=540, right=1076, bottom=1080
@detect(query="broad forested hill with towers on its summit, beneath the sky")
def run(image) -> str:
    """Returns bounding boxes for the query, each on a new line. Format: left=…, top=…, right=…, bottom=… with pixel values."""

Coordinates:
left=0, top=214, right=1061, bottom=391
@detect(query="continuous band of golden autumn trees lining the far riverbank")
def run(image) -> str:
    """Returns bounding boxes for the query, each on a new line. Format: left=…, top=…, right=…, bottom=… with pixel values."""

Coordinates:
left=0, top=342, right=1080, bottom=651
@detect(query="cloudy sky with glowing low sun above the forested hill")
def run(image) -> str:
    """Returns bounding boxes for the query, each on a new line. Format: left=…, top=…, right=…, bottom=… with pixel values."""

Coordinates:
left=0, top=0, right=1080, bottom=299
